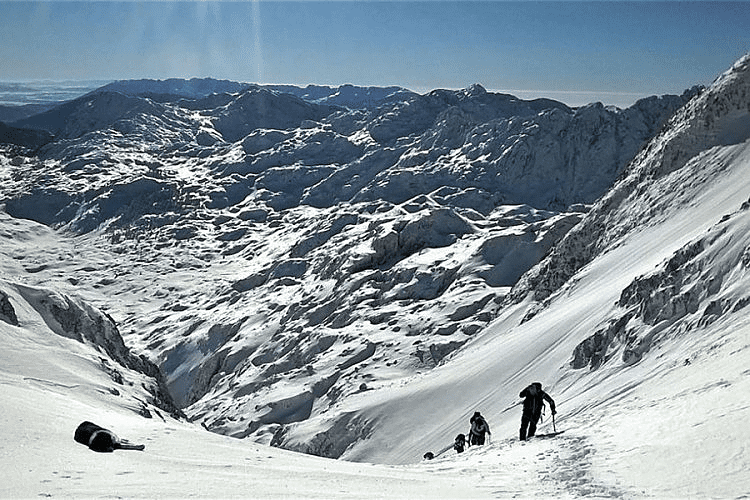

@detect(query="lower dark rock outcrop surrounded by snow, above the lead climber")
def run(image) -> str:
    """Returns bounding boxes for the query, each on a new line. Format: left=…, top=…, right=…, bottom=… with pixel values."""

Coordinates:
left=571, top=193, right=750, bottom=369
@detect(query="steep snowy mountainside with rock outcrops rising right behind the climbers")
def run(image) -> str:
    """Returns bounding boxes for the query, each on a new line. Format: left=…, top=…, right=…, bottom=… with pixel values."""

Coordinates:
left=314, top=53, right=750, bottom=498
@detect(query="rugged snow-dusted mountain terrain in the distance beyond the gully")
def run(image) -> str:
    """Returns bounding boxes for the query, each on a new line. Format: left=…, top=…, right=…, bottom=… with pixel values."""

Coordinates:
left=1, top=75, right=690, bottom=457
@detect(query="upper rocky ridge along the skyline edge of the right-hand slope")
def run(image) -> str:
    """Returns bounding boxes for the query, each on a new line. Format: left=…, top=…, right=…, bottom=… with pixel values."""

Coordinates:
left=512, top=56, right=750, bottom=301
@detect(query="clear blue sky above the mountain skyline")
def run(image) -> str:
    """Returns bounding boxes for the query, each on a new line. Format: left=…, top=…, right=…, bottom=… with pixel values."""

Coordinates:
left=0, top=0, right=750, bottom=106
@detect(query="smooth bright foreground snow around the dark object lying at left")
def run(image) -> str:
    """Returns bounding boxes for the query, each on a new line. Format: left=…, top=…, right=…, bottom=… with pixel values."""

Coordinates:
left=0, top=282, right=489, bottom=498
